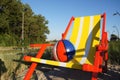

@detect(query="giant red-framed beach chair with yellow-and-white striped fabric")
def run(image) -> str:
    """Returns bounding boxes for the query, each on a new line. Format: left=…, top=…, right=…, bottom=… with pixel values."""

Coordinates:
left=24, top=13, right=108, bottom=80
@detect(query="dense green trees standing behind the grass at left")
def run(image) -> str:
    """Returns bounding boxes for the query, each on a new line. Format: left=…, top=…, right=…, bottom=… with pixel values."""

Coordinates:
left=0, top=0, right=49, bottom=46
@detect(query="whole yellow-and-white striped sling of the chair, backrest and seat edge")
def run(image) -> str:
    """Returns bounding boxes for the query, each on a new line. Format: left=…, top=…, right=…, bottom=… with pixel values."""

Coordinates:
left=27, top=15, right=101, bottom=69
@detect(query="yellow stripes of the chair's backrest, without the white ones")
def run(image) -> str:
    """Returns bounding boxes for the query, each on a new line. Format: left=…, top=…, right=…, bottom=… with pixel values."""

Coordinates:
left=70, top=15, right=101, bottom=64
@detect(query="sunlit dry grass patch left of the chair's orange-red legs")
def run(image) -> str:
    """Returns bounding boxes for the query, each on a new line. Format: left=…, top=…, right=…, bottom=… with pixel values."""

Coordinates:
left=0, top=47, right=26, bottom=80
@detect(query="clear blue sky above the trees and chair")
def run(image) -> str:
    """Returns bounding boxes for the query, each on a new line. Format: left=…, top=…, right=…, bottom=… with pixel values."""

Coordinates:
left=21, top=0, right=120, bottom=40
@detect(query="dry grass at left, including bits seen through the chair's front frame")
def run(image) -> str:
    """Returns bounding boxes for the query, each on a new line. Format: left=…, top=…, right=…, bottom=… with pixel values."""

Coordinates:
left=0, top=47, right=51, bottom=80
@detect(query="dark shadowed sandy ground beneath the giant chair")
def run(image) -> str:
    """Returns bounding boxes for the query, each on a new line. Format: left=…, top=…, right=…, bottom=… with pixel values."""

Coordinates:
left=36, top=65, right=120, bottom=80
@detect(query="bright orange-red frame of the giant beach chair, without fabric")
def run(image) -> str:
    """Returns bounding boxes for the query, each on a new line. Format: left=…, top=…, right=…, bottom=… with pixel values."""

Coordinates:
left=24, top=13, right=108, bottom=80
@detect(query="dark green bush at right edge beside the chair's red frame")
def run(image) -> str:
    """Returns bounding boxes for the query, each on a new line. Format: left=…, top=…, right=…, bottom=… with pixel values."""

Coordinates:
left=108, top=41, right=120, bottom=65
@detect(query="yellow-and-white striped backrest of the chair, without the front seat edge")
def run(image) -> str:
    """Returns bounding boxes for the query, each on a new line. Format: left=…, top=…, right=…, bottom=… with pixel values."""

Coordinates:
left=70, top=15, right=101, bottom=65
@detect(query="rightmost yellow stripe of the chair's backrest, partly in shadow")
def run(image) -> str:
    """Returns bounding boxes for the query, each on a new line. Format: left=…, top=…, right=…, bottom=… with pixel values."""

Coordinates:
left=86, top=15, right=101, bottom=64
